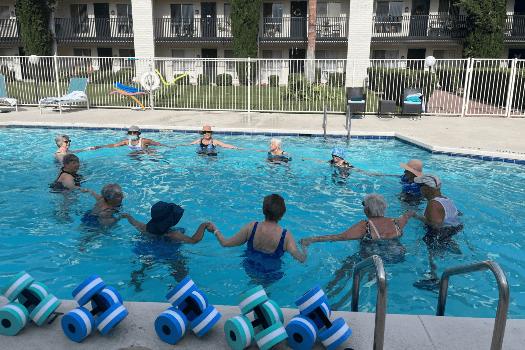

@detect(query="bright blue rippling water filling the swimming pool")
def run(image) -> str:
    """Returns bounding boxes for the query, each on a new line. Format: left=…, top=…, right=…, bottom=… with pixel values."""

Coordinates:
left=0, top=128, right=525, bottom=318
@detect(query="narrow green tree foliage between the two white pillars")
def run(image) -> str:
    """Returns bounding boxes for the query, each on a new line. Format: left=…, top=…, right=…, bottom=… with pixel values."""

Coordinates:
left=231, top=0, right=262, bottom=58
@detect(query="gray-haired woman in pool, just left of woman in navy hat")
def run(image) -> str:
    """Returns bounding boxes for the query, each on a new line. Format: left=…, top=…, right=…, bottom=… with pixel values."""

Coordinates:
left=81, top=184, right=124, bottom=227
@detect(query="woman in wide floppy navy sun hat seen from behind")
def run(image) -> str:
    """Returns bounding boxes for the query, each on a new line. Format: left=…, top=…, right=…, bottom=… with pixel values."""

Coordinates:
left=121, top=201, right=213, bottom=244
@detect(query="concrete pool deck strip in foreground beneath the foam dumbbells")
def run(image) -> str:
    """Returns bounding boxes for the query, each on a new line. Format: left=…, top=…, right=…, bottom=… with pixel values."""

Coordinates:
left=0, top=301, right=525, bottom=350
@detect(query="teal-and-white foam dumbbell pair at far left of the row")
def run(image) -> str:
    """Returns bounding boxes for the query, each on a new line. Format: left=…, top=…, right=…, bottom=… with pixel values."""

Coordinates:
left=0, top=271, right=61, bottom=335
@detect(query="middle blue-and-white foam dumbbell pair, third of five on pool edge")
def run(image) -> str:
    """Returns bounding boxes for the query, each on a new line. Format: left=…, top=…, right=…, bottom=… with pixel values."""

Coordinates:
left=155, top=277, right=221, bottom=345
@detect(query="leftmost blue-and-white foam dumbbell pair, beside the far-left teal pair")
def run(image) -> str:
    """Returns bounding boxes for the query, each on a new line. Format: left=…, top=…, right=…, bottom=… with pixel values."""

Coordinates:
left=62, top=275, right=128, bottom=343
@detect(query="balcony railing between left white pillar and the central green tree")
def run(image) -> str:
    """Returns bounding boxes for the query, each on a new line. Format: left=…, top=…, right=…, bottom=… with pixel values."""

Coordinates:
left=155, top=18, right=232, bottom=42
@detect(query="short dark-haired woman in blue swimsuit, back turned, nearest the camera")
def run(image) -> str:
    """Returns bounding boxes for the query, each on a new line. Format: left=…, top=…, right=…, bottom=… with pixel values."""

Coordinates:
left=212, top=194, right=306, bottom=286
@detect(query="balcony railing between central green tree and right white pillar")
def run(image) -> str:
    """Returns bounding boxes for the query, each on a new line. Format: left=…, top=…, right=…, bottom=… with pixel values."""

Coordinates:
left=260, top=17, right=348, bottom=42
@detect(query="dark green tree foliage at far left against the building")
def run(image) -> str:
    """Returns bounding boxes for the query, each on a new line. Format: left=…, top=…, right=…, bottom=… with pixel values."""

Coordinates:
left=15, top=0, right=55, bottom=56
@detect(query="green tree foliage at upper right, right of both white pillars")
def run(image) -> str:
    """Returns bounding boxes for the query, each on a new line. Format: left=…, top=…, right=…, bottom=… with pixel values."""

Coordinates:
left=455, top=0, right=506, bottom=58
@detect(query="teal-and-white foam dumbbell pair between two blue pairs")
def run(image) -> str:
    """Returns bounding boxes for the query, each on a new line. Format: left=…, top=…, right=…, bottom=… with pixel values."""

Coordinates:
left=224, top=286, right=287, bottom=350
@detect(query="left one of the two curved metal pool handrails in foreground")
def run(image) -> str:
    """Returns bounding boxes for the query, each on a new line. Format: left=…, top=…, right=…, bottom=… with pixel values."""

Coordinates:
left=351, top=255, right=386, bottom=350
